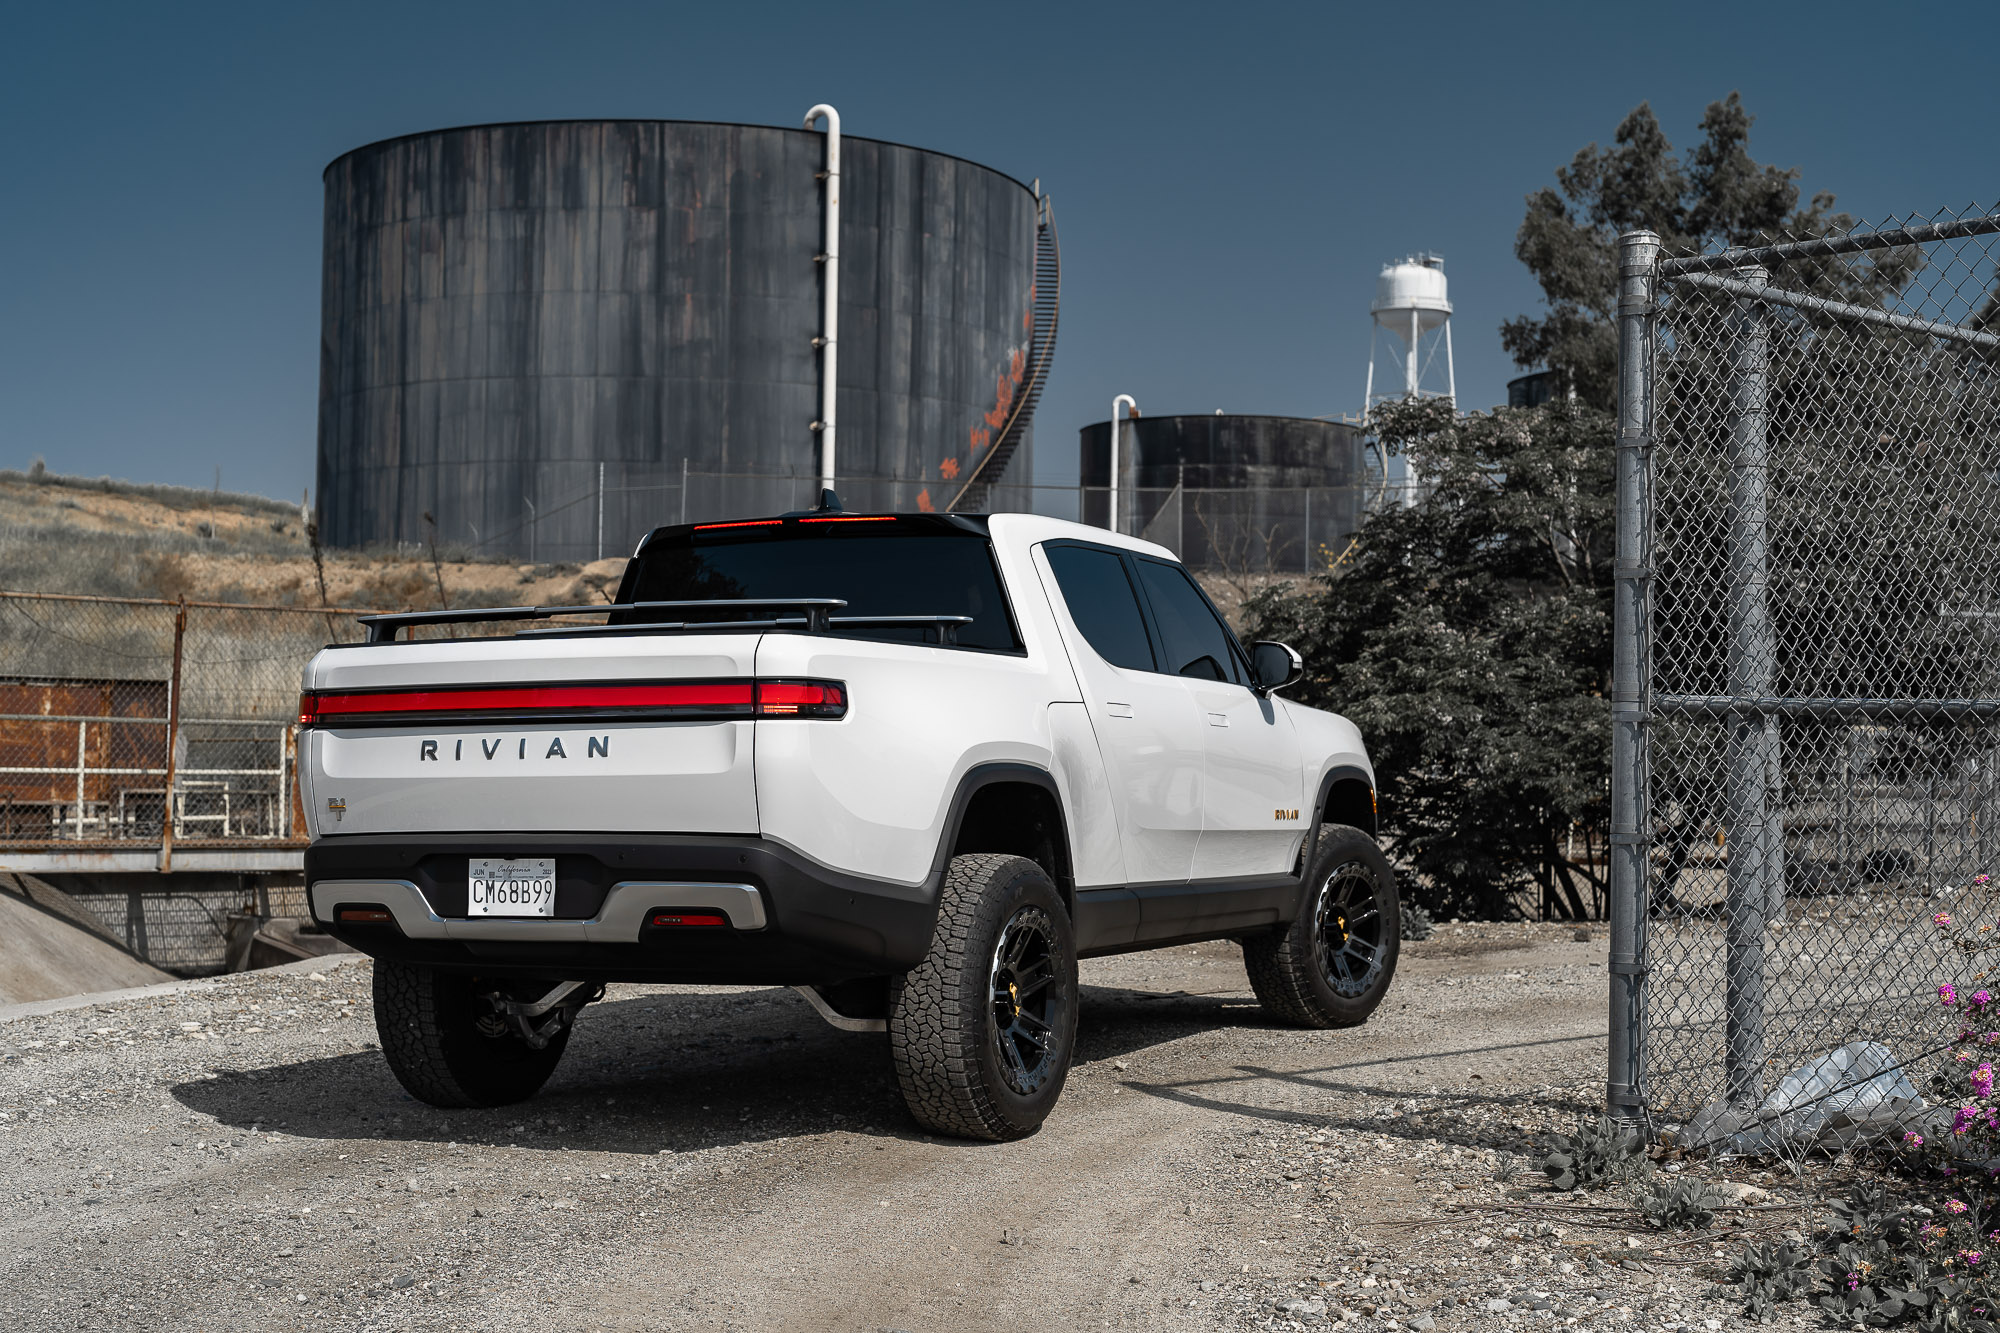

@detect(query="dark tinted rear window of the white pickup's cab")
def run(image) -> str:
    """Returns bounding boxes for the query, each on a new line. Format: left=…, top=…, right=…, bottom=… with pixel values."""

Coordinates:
left=618, top=518, right=1020, bottom=652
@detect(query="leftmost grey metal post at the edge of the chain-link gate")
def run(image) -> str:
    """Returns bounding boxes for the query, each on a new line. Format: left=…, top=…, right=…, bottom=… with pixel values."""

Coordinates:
left=1604, top=232, right=1660, bottom=1119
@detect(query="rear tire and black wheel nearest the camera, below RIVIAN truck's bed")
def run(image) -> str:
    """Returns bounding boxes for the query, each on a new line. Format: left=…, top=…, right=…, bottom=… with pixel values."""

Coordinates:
left=888, top=853, right=1076, bottom=1141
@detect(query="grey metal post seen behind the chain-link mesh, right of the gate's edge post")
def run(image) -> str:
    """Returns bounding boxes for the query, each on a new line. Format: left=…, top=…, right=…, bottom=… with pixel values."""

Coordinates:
left=1724, top=266, right=1784, bottom=1107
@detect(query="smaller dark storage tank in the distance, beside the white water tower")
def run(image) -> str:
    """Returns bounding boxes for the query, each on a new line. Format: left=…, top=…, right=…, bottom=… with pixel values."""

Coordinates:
left=1078, top=412, right=1382, bottom=574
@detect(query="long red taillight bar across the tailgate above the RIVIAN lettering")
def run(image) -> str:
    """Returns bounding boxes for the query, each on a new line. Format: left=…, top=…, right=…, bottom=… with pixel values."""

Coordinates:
left=298, top=681, right=848, bottom=727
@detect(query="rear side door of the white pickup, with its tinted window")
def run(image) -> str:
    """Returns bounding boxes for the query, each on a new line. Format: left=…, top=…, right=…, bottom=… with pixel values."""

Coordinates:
left=1040, top=542, right=1204, bottom=885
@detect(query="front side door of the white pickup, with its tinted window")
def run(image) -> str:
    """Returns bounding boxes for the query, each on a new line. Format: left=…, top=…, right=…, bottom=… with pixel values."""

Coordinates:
left=1134, top=556, right=1312, bottom=883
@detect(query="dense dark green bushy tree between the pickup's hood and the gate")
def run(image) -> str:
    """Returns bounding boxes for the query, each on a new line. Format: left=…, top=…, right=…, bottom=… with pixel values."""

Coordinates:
left=1246, top=400, right=1612, bottom=919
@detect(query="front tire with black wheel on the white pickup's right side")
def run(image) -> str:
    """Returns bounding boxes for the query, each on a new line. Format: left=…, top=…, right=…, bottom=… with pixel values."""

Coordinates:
left=1242, top=825, right=1402, bottom=1027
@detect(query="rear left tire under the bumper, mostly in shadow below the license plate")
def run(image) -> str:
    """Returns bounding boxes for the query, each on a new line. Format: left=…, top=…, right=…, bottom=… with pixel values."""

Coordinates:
left=374, top=959, right=570, bottom=1107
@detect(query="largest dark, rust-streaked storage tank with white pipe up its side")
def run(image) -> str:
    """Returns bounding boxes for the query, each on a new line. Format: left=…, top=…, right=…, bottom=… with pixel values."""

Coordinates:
left=318, top=120, right=1052, bottom=560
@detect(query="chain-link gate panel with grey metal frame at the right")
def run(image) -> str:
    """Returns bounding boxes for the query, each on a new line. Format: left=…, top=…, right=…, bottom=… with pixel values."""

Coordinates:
left=1606, top=212, right=2000, bottom=1121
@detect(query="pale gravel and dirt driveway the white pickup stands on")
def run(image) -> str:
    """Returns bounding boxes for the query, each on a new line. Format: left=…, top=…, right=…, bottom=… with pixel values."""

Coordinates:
left=0, top=927, right=1810, bottom=1333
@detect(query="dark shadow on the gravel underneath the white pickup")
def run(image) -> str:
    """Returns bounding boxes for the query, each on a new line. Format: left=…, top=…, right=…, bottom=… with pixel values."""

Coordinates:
left=170, top=987, right=1270, bottom=1155
